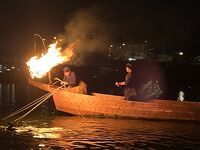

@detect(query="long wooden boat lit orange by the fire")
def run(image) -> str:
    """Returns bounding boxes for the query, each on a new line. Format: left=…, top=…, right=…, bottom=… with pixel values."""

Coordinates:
left=29, top=80, right=200, bottom=121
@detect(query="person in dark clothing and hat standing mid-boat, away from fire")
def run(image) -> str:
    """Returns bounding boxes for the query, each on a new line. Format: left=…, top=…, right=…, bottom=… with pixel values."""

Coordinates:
left=115, top=63, right=136, bottom=100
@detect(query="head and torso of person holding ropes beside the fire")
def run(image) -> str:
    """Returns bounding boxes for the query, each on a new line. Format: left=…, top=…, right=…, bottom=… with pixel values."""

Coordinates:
left=61, top=66, right=77, bottom=87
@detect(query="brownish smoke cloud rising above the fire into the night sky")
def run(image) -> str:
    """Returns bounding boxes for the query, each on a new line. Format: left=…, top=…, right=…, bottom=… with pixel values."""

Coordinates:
left=56, top=7, right=109, bottom=65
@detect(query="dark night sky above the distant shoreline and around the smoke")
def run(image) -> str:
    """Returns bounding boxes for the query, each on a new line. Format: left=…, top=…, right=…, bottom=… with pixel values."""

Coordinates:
left=0, top=0, right=200, bottom=58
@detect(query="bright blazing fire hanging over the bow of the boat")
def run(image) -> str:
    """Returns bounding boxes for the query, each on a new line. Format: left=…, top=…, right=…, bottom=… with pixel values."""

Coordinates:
left=26, top=42, right=76, bottom=78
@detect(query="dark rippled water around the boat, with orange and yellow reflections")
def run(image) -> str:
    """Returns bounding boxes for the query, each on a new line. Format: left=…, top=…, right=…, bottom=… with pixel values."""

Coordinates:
left=0, top=82, right=200, bottom=150
